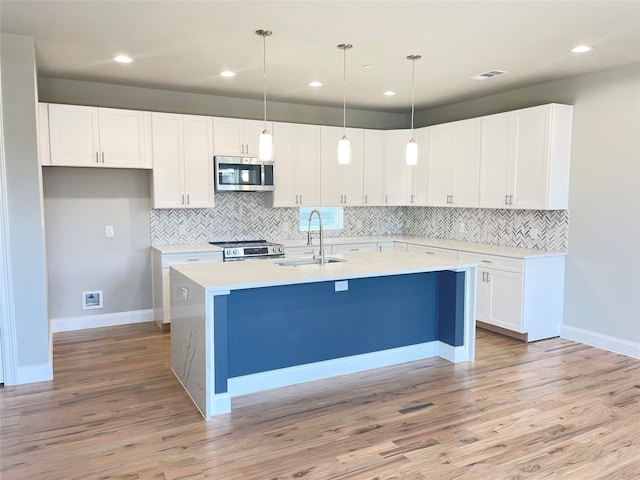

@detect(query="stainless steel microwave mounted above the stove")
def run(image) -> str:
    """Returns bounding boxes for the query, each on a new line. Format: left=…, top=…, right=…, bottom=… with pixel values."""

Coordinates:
left=213, top=156, right=274, bottom=192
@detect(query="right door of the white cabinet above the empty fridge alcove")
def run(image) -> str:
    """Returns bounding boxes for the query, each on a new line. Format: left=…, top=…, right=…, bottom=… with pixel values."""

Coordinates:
left=98, top=108, right=151, bottom=168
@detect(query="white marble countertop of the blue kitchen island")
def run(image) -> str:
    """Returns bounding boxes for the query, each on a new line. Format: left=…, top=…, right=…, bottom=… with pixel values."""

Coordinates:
left=171, top=252, right=475, bottom=294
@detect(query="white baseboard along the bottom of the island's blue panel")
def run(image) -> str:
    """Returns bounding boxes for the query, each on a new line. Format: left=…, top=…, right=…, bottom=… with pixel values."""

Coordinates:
left=227, top=341, right=440, bottom=397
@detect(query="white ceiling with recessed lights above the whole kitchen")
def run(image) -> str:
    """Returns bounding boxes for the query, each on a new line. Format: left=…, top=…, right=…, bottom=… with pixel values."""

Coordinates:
left=0, top=0, right=640, bottom=112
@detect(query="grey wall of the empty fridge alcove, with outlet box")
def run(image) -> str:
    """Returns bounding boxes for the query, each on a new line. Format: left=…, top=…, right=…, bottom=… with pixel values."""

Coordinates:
left=43, top=167, right=153, bottom=321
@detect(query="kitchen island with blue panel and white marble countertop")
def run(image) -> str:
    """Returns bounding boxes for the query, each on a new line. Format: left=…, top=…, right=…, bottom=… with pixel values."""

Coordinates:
left=170, top=252, right=476, bottom=419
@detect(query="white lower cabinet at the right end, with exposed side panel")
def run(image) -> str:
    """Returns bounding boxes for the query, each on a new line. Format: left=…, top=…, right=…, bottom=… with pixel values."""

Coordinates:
left=458, top=252, right=565, bottom=342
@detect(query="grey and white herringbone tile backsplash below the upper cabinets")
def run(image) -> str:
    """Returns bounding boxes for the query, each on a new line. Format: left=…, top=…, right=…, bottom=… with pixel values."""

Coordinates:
left=150, top=192, right=569, bottom=251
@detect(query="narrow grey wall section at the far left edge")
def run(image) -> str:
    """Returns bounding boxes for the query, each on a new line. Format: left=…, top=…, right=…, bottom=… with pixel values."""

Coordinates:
left=0, top=33, right=53, bottom=383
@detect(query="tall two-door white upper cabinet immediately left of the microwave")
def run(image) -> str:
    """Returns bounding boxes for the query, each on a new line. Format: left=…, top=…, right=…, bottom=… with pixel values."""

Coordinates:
left=152, top=113, right=214, bottom=208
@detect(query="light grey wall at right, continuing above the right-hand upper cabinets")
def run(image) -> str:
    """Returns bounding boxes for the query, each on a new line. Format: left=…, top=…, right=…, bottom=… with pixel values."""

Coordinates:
left=420, top=65, right=640, bottom=357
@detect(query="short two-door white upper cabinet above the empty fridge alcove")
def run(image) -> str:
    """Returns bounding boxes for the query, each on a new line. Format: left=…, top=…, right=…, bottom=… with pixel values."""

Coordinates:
left=49, top=104, right=151, bottom=168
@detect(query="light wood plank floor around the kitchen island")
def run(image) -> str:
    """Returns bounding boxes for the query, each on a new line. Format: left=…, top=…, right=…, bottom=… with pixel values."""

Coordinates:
left=0, top=324, right=640, bottom=480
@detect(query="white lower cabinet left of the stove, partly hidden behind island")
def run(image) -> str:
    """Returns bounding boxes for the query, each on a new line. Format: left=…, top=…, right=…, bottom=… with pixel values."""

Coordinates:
left=151, top=248, right=222, bottom=331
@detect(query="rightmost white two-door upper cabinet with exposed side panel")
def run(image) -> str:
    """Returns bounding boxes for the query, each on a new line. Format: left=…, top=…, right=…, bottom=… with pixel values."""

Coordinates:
left=480, top=104, right=573, bottom=210
